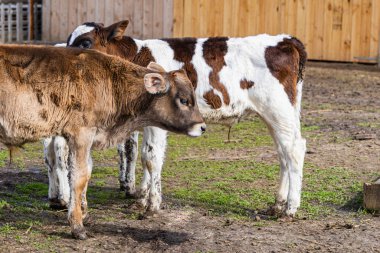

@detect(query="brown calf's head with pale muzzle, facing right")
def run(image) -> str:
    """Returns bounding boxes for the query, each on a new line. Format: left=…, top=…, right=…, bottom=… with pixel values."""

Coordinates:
left=144, top=62, right=206, bottom=137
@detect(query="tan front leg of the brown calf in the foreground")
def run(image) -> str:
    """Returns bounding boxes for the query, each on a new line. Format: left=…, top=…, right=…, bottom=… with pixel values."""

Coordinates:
left=68, top=129, right=95, bottom=239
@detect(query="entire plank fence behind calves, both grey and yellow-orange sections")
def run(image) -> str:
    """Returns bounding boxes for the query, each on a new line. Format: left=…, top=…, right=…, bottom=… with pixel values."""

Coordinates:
left=43, top=0, right=380, bottom=63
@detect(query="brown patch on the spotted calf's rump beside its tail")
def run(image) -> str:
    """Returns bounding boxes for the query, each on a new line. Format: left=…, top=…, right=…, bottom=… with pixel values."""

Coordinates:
left=265, top=38, right=306, bottom=105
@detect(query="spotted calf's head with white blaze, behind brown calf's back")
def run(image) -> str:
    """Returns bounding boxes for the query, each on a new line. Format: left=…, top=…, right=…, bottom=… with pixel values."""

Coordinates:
left=67, top=20, right=137, bottom=58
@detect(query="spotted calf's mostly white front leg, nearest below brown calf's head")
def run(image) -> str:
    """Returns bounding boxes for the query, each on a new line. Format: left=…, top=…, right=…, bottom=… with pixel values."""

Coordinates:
left=139, top=127, right=167, bottom=212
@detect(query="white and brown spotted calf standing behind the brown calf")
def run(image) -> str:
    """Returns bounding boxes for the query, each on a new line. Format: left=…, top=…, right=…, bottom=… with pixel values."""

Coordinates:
left=47, top=21, right=306, bottom=215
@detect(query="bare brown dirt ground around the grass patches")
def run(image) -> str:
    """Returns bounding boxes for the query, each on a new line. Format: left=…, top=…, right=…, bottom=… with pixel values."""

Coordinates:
left=0, top=62, right=380, bottom=252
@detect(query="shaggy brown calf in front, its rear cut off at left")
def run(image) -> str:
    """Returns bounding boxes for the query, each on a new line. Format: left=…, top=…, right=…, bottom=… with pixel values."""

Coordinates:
left=0, top=45, right=205, bottom=239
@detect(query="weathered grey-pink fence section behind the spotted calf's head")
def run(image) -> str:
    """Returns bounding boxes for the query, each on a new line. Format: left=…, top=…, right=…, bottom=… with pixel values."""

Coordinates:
left=42, top=0, right=173, bottom=41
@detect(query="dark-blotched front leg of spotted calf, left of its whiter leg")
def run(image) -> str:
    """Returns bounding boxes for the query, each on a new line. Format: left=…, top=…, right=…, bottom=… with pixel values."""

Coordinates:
left=117, top=131, right=139, bottom=197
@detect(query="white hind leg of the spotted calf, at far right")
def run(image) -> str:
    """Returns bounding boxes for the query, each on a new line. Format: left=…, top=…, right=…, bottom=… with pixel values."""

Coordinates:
left=255, top=84, right=306, bottom=216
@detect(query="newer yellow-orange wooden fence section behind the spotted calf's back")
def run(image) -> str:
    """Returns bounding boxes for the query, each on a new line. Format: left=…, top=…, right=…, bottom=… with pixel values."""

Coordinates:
left=173, top=0, right=380, bottom=62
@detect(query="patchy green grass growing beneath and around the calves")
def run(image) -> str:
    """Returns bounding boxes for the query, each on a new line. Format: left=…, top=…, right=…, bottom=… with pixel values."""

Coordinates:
left=0, top=113, right=374, bottom=227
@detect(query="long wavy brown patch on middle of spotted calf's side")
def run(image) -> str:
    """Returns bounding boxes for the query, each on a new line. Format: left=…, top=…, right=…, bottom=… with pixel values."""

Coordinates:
left=203, top=37, right=230, bottom=105
